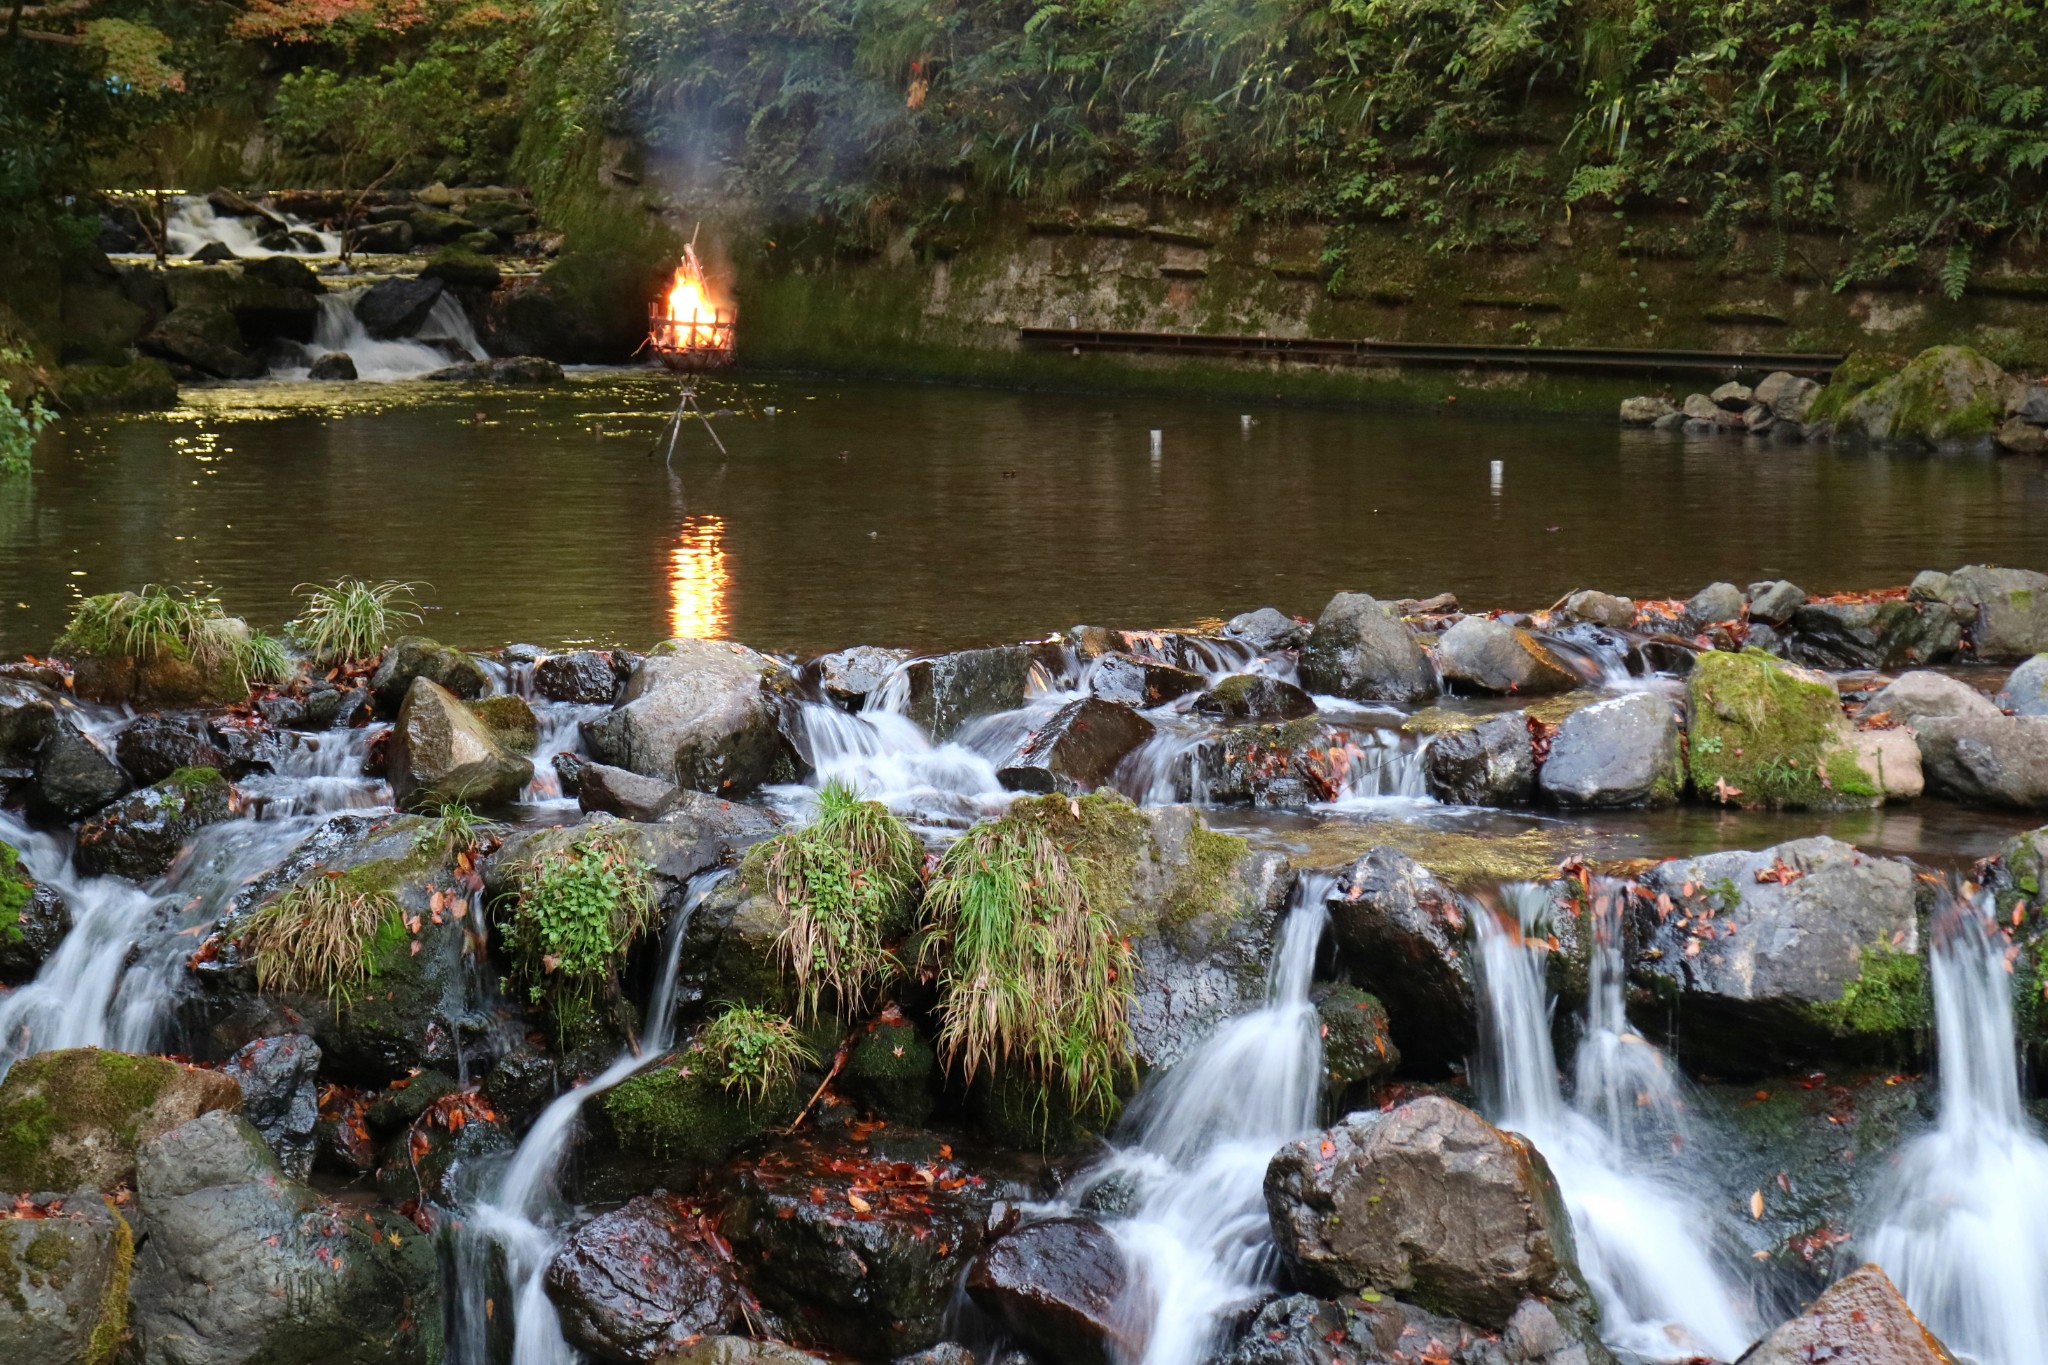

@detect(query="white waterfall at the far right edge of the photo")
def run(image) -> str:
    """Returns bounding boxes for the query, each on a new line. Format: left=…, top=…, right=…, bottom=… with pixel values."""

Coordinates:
left=1864, top=896, right=2048, bottom=1365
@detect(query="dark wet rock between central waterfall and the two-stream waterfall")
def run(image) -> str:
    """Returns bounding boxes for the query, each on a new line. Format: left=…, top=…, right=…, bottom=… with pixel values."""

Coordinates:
left=1329, top=847, right=1479, bottom=1068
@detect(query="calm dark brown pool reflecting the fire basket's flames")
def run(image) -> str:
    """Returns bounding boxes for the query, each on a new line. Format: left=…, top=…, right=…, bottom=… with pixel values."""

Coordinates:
left=0, top=372, right=2048, bottom=653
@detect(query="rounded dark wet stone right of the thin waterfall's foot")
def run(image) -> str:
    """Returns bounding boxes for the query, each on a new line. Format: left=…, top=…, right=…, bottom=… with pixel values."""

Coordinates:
left=545, top=1195, right=739, bottom=1361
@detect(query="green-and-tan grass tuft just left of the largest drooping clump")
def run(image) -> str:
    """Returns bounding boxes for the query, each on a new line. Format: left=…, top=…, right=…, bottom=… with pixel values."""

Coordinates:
left=750, top=782, right=924, bottom=1019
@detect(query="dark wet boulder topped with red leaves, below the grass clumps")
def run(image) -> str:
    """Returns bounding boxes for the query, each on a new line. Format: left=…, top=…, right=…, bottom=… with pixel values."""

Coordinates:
left=719, top=1132, right=991, bottom=1359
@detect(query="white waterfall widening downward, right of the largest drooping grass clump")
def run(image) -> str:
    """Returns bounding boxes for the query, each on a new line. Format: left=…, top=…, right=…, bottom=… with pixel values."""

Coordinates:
left=1087, top=874, right=1335, bottom=1365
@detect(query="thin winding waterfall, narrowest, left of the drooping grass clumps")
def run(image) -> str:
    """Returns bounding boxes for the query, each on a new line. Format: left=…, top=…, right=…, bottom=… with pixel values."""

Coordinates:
left=449, top=868, right=729, bottom=1365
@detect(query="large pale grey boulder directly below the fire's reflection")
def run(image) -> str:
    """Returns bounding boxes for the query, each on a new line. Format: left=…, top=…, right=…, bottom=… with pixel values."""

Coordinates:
left=582, top=639, right=795, bottom=796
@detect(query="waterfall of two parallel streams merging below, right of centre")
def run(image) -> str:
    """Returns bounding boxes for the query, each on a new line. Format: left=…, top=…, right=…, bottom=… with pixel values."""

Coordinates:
left=1475, top=886, right=1757, bottom=1361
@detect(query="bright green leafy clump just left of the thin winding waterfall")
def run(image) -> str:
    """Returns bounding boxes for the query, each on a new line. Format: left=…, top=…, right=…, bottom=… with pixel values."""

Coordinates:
left=506, top=829, right=655, bottom=1025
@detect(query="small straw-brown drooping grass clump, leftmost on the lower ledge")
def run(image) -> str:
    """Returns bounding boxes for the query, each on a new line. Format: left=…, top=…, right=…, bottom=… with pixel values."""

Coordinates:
left=242, top=872, right=403, bottom=1005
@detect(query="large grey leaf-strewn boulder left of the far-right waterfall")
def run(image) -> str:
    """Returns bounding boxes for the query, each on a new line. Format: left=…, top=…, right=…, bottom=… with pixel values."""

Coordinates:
left=1630, top=837, right=1927, bottom=1072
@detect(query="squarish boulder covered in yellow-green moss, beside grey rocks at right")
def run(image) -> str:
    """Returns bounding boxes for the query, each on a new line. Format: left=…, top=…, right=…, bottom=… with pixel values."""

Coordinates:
left=1686, top=649, right=1884, bottom=810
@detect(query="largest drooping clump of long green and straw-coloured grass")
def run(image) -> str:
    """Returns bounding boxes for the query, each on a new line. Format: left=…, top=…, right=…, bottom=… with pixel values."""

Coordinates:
left=922, top=819, right=1133, bottom=1111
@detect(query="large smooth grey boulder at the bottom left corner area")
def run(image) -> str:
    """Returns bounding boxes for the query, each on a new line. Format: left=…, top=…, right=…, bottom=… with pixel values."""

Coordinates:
left=131, top=1113, right=440, bottom=1365
